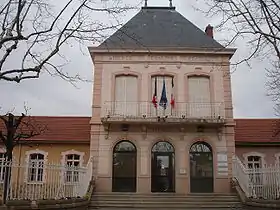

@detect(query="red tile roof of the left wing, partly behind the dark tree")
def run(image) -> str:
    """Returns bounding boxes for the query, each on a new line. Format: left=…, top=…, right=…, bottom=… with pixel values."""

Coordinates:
left=0, top=116, right=90, bottom=143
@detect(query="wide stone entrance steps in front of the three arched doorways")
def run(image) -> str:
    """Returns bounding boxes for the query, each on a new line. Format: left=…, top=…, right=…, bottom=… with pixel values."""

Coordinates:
left=89, top=193, right=243, bottom=210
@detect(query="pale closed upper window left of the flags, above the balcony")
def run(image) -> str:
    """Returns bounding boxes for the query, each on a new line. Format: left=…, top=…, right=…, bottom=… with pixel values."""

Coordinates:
left=114, top=75, right=139, bottom=116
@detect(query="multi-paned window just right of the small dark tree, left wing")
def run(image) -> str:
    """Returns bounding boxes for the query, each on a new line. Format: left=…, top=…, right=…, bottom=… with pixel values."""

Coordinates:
left=27, top=153, right=45, bottom=182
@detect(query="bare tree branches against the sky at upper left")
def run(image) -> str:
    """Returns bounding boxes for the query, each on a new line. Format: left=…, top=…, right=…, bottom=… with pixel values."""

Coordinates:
left=0, top=0, right=138, bottom=83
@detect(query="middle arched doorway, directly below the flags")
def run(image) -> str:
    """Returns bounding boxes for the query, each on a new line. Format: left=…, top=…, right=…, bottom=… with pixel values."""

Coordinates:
left=151, top=141, right=175, bottom=192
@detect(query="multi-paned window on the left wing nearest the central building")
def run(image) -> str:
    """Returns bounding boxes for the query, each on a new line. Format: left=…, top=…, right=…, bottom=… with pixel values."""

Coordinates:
left=65, top=154, right=81, bottom=182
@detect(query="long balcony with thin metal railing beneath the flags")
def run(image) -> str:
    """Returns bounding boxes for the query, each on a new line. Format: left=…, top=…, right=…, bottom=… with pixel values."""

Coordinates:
left=101, top=101, right=225, bottom=124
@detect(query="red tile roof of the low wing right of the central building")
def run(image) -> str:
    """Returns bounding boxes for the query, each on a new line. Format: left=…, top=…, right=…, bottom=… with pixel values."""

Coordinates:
left=235, top=119, right=280, bottom=143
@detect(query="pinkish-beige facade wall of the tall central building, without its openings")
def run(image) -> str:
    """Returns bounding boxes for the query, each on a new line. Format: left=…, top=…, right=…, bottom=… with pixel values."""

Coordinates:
left=90, top=48, right=235, bottom=193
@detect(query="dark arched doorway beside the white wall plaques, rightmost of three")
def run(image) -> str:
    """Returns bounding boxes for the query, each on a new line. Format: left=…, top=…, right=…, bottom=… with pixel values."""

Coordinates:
left=190, top=142, right=214, bottom=193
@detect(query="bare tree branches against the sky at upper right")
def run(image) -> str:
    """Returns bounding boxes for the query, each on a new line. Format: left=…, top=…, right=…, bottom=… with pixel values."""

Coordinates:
left=200, top=0, right=280, bottom=110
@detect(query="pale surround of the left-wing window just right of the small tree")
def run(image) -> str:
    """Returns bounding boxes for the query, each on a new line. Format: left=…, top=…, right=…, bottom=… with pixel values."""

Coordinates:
left=25, top=149, right=48, bottom=184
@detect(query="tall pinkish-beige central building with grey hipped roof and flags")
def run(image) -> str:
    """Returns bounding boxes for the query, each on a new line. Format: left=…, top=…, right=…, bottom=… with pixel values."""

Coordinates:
left=89, top=2, right=235, bottom=193
